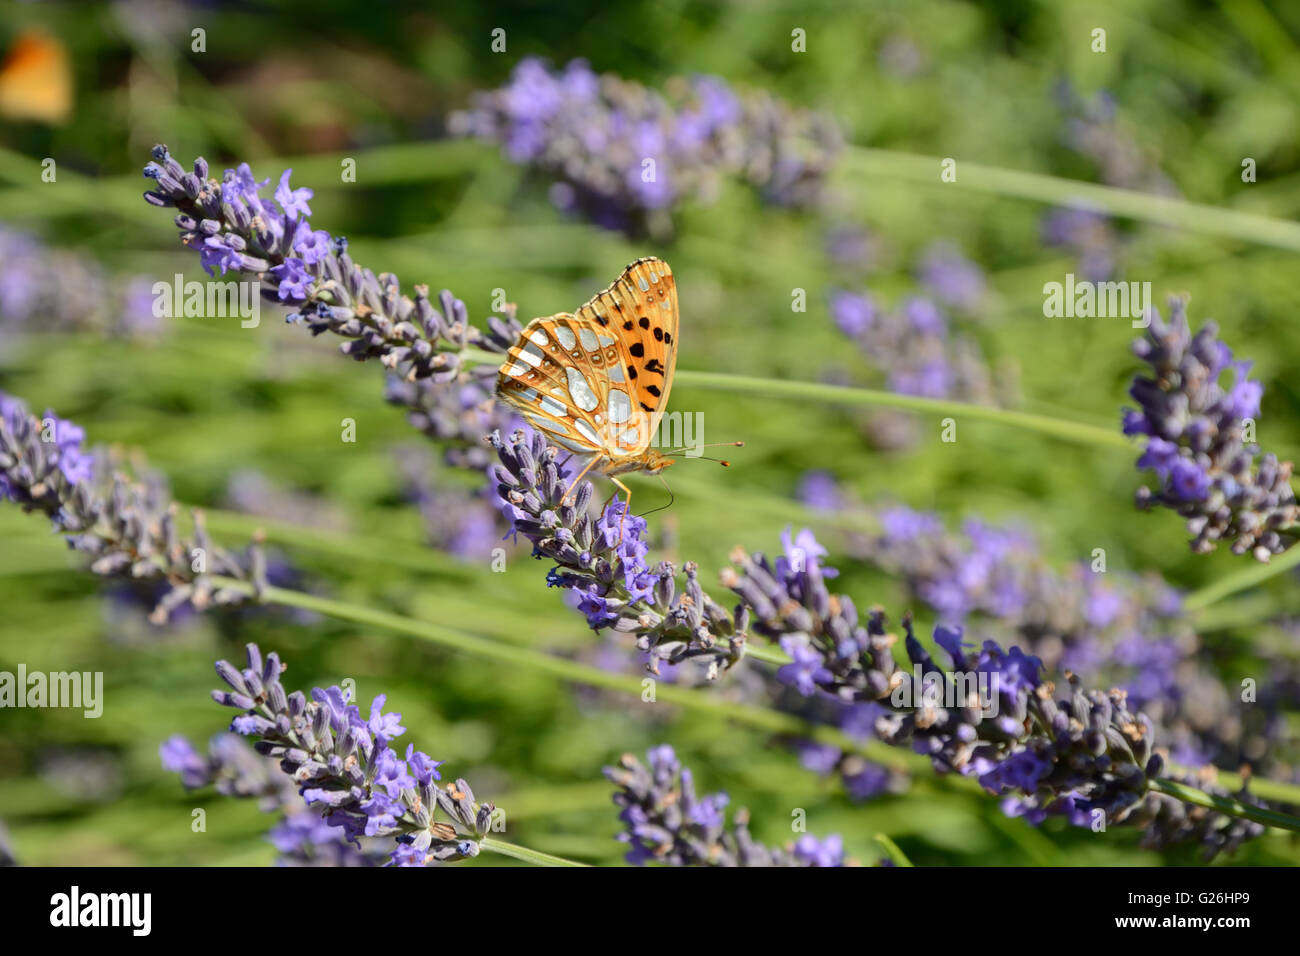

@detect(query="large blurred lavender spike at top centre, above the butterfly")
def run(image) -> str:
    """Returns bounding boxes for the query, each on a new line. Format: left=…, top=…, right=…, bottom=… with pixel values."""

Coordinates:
left=450, top=57, right=840, bottom=233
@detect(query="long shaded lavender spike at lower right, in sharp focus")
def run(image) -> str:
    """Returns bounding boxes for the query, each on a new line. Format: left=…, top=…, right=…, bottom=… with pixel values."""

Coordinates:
left=723, top=532, right=1262, bottom=856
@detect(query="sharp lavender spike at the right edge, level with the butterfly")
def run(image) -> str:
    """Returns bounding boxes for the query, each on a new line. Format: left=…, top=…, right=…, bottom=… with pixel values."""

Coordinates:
left=1123, top=299, right=1300, bottom=561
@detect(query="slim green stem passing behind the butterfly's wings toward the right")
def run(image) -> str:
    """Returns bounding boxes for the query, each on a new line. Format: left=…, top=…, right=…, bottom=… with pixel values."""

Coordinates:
left=460, top=349, right=1132, bottom=449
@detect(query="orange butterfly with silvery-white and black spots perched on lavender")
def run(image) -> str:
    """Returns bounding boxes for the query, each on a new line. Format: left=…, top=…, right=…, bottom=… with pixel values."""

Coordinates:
left=497, top=258, right=677, bottom=540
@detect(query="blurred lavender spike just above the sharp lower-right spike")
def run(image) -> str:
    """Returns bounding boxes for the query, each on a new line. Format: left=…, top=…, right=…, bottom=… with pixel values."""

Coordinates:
left=821, top=494, right=1262, bottom=770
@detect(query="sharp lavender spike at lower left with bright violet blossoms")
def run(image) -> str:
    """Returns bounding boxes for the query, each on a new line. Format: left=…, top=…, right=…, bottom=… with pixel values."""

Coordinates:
left=212, top=644, right=495, bottom=866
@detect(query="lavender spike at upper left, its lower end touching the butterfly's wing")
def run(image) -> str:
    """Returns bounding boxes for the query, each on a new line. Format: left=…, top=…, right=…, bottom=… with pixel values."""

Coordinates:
left=144, top=146, right=521, bottom=481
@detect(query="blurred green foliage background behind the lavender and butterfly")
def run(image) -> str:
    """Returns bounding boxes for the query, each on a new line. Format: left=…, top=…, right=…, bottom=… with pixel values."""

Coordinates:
left=0, top=0, right=1300, bottom=865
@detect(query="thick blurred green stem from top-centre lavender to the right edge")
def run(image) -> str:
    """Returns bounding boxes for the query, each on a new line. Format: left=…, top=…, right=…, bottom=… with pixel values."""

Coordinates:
left=844, top=147, right=1300, bottom=250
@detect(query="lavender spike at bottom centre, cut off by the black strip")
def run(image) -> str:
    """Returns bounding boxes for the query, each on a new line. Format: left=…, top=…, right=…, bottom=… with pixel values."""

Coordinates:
left=605, top=744, right=845, bottom=866
